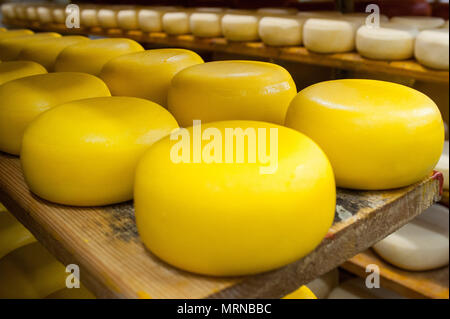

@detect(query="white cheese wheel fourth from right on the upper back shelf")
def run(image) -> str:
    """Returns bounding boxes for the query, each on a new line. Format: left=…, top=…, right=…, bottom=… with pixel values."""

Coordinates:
left=258, top=16, right=305, bottom=46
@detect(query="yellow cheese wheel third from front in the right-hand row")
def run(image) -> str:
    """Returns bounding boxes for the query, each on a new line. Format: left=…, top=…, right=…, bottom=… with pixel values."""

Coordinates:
left=100, top=49, right=203, bottom=106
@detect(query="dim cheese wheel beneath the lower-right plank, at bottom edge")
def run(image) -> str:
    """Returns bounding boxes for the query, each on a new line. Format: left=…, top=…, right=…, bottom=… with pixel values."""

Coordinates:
left=328, top=278, right=404, bottom=299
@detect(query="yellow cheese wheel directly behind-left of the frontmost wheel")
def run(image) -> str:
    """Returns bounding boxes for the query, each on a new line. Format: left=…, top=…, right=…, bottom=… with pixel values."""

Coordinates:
left=20, top=97, right=178, bottom=206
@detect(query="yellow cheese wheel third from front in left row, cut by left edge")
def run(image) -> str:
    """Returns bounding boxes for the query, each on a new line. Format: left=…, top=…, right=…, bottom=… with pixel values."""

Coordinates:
left=0, top=72, right=110, bottom=155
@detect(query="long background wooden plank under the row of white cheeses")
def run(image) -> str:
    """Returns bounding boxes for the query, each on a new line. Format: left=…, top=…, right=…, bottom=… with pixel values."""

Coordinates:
left=4, top=21, right=449, bottom=83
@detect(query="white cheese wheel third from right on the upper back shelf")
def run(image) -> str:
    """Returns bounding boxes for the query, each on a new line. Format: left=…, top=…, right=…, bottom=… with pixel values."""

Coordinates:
left=303, top=18, right=356, bottom=53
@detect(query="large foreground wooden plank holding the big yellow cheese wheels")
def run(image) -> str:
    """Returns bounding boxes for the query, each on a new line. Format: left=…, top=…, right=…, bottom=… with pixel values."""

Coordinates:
left=0, top=153, right=442, bottom=298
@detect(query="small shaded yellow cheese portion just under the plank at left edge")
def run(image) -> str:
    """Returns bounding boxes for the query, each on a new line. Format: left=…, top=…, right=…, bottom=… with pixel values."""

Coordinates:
left=0, top=207, right=36, bottom=260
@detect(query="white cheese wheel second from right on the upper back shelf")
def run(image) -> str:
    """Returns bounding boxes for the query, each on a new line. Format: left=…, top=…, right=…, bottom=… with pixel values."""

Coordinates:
left=356, top=26, right=416, bottom=60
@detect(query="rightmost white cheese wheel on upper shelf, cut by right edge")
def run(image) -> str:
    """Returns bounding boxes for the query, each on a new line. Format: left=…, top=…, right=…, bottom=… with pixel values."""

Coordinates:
left=414, top=29, right=449, bottom=70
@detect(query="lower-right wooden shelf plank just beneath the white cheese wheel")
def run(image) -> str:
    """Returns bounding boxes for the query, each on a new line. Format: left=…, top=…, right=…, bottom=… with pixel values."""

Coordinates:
left=341, top=250, right=449, bottom=299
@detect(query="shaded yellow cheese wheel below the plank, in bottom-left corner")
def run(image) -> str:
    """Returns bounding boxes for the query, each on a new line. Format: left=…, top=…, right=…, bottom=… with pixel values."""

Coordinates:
left=0, top=242, right=68, bottom=299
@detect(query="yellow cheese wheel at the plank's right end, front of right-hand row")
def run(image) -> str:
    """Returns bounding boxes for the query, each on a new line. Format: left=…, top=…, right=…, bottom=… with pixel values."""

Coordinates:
left=286, top=79, right=444, bottom=190
